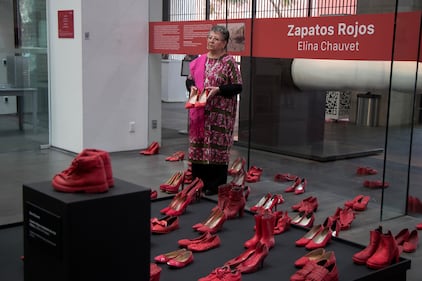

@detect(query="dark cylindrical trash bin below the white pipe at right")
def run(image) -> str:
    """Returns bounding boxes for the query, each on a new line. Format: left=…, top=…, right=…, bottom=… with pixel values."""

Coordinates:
left=356, top=93, right=381, bottom=127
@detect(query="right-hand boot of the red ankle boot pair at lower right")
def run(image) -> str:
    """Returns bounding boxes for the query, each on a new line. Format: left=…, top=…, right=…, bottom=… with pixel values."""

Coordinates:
left=366, top=231, right=399, bottom=269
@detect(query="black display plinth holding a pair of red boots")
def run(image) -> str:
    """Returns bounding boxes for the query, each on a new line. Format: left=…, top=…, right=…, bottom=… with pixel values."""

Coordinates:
left=23, top=179, right=151, bottom=281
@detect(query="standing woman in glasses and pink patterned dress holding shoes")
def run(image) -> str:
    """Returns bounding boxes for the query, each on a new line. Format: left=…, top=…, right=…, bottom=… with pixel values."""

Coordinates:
left=186, top=25, right=242, bottom=195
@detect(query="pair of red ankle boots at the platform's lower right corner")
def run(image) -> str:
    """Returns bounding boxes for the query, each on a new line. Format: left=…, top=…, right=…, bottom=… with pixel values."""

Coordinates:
left=352, top=226, right=400, bottom=269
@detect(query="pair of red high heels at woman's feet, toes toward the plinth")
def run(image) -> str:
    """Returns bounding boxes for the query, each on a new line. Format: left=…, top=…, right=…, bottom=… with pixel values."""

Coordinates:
left=160, top=178, right=204, bottom=216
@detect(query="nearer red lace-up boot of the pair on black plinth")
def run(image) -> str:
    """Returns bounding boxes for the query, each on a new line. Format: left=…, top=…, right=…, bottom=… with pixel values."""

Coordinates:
left=52, top=155, right=108, bottom=193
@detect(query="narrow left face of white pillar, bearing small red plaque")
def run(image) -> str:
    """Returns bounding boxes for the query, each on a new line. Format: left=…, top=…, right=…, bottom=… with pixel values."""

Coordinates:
left=47, top=0, right=83, bottom=152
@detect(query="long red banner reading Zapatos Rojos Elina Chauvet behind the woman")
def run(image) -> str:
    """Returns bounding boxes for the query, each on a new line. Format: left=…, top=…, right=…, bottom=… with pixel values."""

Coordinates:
left=149, top=11, right=421, bottom=61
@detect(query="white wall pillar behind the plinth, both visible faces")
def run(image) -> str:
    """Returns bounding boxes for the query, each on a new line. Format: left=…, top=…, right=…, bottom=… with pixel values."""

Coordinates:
left=49, top=0, right=149, bottom=152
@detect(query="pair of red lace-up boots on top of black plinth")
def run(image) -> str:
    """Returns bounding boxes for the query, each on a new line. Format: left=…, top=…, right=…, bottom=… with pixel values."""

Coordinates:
left=52, top=149, right=114, bottom=193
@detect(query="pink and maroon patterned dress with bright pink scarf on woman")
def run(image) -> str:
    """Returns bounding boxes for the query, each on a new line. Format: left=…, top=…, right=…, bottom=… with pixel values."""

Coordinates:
left=189, top=54, right=242, bottom=165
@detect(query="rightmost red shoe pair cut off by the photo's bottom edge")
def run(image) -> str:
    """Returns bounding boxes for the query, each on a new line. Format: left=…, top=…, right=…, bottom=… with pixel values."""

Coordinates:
left=290, top=251, right=339, bottom=281
